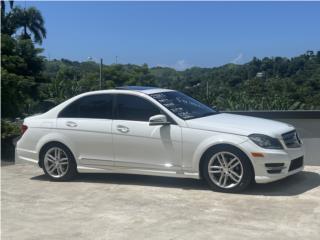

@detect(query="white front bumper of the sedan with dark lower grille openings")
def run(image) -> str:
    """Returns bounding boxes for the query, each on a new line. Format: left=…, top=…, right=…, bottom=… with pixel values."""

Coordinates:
left=241, top=140, right=304, bottom=183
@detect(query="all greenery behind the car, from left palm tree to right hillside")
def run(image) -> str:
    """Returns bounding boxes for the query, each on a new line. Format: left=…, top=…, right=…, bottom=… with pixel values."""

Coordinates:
left=1, top=1, right=320, bottom=124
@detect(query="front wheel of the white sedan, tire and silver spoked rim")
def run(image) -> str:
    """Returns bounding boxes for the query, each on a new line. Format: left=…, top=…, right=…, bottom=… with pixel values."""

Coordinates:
left=201, top=145, right=254, bottom=193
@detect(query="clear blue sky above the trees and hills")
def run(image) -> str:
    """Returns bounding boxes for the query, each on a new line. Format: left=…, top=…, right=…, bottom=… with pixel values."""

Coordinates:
left=16, top=1, right=320, bottom=70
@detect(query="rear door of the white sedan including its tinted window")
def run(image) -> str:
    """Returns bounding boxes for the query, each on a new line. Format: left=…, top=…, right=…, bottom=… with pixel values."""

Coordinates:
left=57, top=94, right=114, bottom=167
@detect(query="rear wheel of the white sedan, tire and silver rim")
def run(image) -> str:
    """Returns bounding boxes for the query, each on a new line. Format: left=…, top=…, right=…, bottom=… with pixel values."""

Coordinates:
left=40, top=143, right=78, bottom=181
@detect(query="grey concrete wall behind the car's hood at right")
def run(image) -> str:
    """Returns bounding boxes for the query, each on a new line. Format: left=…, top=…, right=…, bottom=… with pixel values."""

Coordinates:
left=225, top=111, right=320, bottom=166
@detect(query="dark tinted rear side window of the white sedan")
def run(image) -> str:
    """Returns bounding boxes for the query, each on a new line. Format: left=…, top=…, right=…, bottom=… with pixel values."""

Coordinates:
left=59, top=94, right=113, bottom=119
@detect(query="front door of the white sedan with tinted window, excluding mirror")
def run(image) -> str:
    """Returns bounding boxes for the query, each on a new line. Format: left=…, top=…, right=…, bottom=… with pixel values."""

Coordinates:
left=112, top=94, right=181, bottom=170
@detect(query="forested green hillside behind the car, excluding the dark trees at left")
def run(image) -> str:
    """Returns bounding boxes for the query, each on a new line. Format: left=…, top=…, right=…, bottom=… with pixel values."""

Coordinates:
left=42, top=52, right=320, bottom=110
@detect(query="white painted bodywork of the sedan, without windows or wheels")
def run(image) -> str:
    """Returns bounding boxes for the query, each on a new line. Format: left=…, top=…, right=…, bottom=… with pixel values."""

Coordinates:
left=16, top=89, right=304, bottom=183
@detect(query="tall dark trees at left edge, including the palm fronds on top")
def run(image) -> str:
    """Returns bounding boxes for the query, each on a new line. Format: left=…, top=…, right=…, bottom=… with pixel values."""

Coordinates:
left=1, top=1, right=46, bottom=118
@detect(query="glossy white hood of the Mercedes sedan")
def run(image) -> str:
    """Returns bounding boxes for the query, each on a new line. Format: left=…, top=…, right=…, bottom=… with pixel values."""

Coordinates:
left=186, top=113, right=294, bottom=137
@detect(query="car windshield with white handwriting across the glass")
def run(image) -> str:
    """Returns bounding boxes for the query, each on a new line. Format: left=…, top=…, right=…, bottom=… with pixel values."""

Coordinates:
left=149, top=91, right=217, bottom=120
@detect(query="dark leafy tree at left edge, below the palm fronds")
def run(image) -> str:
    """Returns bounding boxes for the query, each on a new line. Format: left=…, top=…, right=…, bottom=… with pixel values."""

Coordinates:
left=1, top=34, right=43, bottom=118
